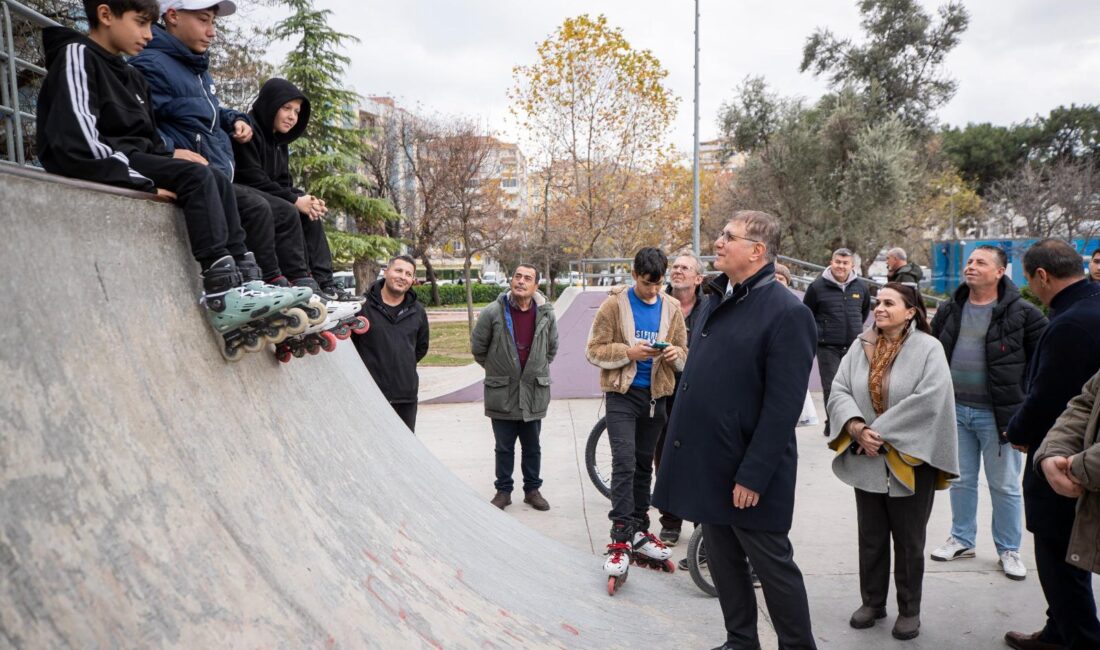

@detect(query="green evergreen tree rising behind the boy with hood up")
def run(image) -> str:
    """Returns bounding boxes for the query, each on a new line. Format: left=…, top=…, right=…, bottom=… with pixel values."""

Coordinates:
left=274, top=0, right=399, bottom=269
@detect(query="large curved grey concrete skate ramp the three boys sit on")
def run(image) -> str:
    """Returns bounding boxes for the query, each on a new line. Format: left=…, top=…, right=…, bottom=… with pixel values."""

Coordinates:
left=0, top=172, right=723, bottom=648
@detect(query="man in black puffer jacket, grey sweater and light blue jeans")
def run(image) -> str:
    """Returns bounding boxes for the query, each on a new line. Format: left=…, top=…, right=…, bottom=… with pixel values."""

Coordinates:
left=932, top=246, right=1046, bottom=580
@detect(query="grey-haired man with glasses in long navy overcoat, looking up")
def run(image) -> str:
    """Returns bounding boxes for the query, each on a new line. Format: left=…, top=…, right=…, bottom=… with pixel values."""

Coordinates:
left=653, top=211, right=817, bottom=650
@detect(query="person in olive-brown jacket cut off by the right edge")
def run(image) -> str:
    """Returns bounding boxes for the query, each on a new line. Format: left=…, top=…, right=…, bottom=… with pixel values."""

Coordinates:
left=1035, top=373, right=1100, bottom=573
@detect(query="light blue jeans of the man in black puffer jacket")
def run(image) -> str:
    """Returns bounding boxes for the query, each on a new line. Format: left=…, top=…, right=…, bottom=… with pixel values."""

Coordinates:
left=949, top=404, right=1024, bottom=554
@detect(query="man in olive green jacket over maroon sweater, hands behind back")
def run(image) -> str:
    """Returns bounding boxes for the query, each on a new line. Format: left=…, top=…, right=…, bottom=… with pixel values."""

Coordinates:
left=470, top=264, right=558, bottom=510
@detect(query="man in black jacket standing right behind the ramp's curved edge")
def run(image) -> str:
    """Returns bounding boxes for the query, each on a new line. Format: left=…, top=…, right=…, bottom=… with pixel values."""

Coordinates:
left=352, top=255, right=428, bottom=431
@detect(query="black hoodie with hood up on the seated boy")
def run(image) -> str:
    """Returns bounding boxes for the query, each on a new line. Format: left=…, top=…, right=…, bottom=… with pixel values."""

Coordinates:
left=233, top=78, right=309, bottom=203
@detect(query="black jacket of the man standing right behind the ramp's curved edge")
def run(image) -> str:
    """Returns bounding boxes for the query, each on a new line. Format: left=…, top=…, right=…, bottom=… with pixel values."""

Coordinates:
left=352, top=279, right=428, bottom=404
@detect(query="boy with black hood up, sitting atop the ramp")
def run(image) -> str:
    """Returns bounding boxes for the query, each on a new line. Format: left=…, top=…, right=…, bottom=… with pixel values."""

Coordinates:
left=233, top=78, right=362, bottom=302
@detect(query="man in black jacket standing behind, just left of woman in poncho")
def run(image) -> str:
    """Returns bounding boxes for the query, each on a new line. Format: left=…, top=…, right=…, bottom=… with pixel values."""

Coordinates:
left=802, top=249, right=871, bottom=436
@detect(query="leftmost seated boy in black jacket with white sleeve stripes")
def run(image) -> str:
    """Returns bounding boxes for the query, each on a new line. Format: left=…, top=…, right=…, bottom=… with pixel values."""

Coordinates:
left=36, top=0, right=305, bottom=356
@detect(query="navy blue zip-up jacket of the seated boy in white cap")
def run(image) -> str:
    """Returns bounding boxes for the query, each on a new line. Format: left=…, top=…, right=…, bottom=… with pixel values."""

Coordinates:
left=130, top=25, right=251, bottom=178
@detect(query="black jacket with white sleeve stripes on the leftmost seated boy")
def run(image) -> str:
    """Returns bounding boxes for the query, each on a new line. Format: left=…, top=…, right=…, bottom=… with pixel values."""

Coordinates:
left=37, top=27, right=168, bottom=192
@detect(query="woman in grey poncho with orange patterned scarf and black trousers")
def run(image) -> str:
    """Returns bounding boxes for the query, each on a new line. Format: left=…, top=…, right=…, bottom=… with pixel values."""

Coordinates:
left=828, top=283, right=958, bottom=640
